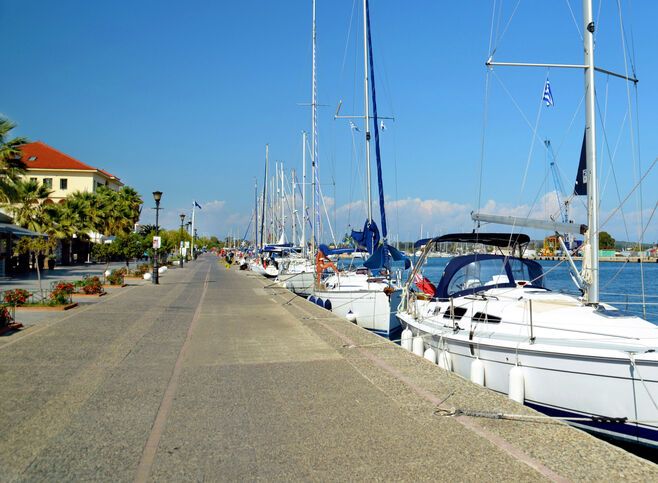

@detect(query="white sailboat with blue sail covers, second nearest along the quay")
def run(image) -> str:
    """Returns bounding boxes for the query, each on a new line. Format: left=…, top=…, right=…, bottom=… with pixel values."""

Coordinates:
left=309, top=0, right=410, bottom=337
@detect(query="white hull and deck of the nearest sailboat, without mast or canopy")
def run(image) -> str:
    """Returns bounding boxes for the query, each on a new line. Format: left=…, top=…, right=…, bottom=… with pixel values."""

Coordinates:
left=399, top=290, right=658, bottom=447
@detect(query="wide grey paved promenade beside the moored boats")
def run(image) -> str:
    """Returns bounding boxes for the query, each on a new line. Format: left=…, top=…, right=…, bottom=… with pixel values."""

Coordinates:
left=0, top=255, right=658, bottom=482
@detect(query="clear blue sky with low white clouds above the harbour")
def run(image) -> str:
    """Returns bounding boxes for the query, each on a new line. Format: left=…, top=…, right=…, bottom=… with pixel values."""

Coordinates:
left=0, top=0, right=658, bottom=241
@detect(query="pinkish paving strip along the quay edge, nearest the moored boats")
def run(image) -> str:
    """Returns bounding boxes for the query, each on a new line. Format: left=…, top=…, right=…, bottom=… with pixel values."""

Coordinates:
left=264, top=284, right=569, bottom=482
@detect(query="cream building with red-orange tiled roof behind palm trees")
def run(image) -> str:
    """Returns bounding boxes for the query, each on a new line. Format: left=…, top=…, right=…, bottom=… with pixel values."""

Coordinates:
left=21, top=141, right=123, bottom=203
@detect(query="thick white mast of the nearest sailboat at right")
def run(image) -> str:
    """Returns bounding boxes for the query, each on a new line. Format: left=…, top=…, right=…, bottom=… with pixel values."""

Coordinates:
left=583, top=0, right=599, bottom=305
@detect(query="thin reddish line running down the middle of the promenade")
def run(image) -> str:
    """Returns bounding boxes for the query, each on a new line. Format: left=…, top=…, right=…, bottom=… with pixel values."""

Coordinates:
left=134, top=265, right=212, bottom=483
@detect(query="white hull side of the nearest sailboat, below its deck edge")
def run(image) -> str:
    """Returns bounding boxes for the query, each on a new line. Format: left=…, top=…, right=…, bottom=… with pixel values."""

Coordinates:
left=400, top=313, right=658, bottom=448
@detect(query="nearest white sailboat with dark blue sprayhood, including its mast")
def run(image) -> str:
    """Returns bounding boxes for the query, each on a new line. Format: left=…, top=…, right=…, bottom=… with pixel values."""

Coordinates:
left=398, top=0, right=658, bottom=448
